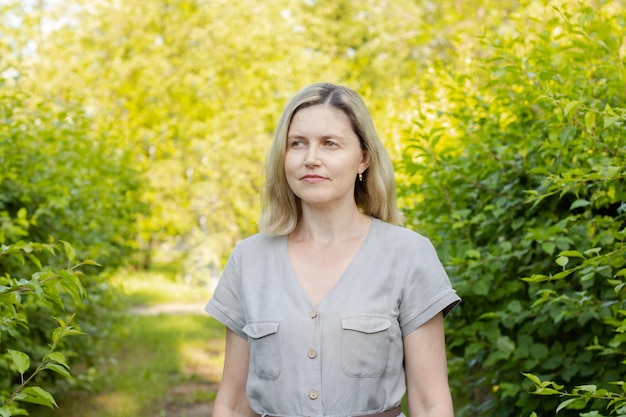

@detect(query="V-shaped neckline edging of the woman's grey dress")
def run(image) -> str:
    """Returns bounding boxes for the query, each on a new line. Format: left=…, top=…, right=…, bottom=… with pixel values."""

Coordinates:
left=282, top=217, right=380, bottom=309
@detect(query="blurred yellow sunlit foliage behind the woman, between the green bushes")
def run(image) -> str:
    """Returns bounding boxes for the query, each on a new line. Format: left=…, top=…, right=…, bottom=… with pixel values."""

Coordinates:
left=9, top=0, right=454, bottom=273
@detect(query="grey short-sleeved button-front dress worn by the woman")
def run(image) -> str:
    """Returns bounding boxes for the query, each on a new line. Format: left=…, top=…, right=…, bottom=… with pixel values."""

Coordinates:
left=205, top=219, right=460, bottom=417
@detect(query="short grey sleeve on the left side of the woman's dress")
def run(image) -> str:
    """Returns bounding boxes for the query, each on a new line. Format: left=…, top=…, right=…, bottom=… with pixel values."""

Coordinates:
left=204, top=247, right=247, bottom=339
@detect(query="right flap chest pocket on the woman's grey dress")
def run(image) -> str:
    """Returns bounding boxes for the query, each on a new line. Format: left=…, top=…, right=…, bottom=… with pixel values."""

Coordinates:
left=341, top=316, right=391, bottom=378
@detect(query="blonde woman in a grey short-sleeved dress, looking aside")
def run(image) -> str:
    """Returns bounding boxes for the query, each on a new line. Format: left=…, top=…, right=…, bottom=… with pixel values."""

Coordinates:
left=206, top=83, right=460, bottom=417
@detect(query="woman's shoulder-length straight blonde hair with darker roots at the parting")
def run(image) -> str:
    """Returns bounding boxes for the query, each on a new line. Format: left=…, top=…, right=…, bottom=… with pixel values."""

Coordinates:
left=259, top=83, right=403, bottom=235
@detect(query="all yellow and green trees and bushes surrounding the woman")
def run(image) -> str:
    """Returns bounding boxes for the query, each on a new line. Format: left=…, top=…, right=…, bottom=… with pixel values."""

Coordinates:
left=0, top=0, right=626, bottom=417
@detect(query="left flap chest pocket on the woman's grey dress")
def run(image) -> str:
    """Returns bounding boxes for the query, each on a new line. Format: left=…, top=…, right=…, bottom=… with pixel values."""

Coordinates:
left=242, top=321, right=281, bottom=380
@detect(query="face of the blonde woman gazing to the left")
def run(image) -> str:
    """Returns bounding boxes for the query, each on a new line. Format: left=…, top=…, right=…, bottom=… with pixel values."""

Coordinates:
left=285, top=104, right=370, bottom=208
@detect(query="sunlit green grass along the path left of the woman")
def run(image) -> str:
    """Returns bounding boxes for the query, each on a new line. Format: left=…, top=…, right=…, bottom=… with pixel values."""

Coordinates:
left=29, top=266, right=224, bottom=417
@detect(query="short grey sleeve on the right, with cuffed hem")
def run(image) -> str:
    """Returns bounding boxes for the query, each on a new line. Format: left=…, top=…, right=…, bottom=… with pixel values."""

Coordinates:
left=399, top=235, right=461, bottom=336
